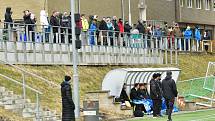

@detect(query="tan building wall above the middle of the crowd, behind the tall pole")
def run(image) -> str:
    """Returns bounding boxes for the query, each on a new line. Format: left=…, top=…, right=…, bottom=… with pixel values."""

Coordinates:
left=48, top=0, right=139, bottom=23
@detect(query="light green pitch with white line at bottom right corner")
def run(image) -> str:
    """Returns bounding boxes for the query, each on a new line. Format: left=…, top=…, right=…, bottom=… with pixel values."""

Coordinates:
left=129, top=109, right=215, bottom=121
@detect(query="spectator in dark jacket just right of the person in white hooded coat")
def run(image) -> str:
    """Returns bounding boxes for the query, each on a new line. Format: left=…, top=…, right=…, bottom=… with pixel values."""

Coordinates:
left=50, top=11, right=60, bottom=43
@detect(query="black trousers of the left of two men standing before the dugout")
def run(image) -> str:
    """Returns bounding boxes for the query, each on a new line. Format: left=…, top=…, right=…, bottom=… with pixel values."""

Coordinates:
left=152, top=99, right=162, bottom=116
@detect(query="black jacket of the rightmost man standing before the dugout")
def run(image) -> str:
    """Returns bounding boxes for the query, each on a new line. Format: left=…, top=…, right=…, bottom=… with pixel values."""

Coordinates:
left=162, top=76, right=178, bottom=99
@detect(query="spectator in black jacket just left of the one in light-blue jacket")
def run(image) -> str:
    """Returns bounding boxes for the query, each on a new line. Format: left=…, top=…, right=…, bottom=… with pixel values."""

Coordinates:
left=98, top=17, right=108, bottom=45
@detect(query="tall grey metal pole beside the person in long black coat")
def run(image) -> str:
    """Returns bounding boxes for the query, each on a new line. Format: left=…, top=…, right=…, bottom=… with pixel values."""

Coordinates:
left=71, top=0, right=80, bottom=118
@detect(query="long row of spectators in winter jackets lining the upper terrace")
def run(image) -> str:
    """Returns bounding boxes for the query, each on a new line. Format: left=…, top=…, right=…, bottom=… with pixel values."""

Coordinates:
left=4, top=7, right=211, bottom=49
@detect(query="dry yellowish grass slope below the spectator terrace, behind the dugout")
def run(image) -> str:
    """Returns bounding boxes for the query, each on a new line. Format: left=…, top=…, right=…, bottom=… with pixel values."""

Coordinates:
left=0, top=55, right=215, bottom=120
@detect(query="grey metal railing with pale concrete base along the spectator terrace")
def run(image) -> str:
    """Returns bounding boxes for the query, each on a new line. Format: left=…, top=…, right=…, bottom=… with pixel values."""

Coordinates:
left=0, top=23, right=211, bottom=65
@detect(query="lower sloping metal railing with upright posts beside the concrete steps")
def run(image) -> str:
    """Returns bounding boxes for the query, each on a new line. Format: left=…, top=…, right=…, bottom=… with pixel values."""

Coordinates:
left=0, top=74, right=43, bottom=120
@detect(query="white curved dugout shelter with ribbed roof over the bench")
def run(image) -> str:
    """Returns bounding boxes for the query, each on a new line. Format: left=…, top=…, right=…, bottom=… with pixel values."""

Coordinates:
left=102, top=68, right=181, bottom=97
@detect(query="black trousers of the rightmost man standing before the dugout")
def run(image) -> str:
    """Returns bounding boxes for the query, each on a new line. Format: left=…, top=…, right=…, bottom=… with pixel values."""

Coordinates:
left=165, top=99, right=175, bottom=120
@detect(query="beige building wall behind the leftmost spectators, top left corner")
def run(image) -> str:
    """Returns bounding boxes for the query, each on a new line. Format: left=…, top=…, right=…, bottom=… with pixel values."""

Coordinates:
left=0, top=0, right=45, bottom=21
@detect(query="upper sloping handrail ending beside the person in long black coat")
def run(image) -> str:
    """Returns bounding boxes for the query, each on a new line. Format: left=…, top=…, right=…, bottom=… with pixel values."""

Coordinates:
left=0, top=60, right=60, bottom=88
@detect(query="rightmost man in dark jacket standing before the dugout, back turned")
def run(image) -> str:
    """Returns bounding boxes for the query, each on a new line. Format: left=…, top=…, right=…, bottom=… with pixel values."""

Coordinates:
left=162, top=71, right=178, bottom=121
